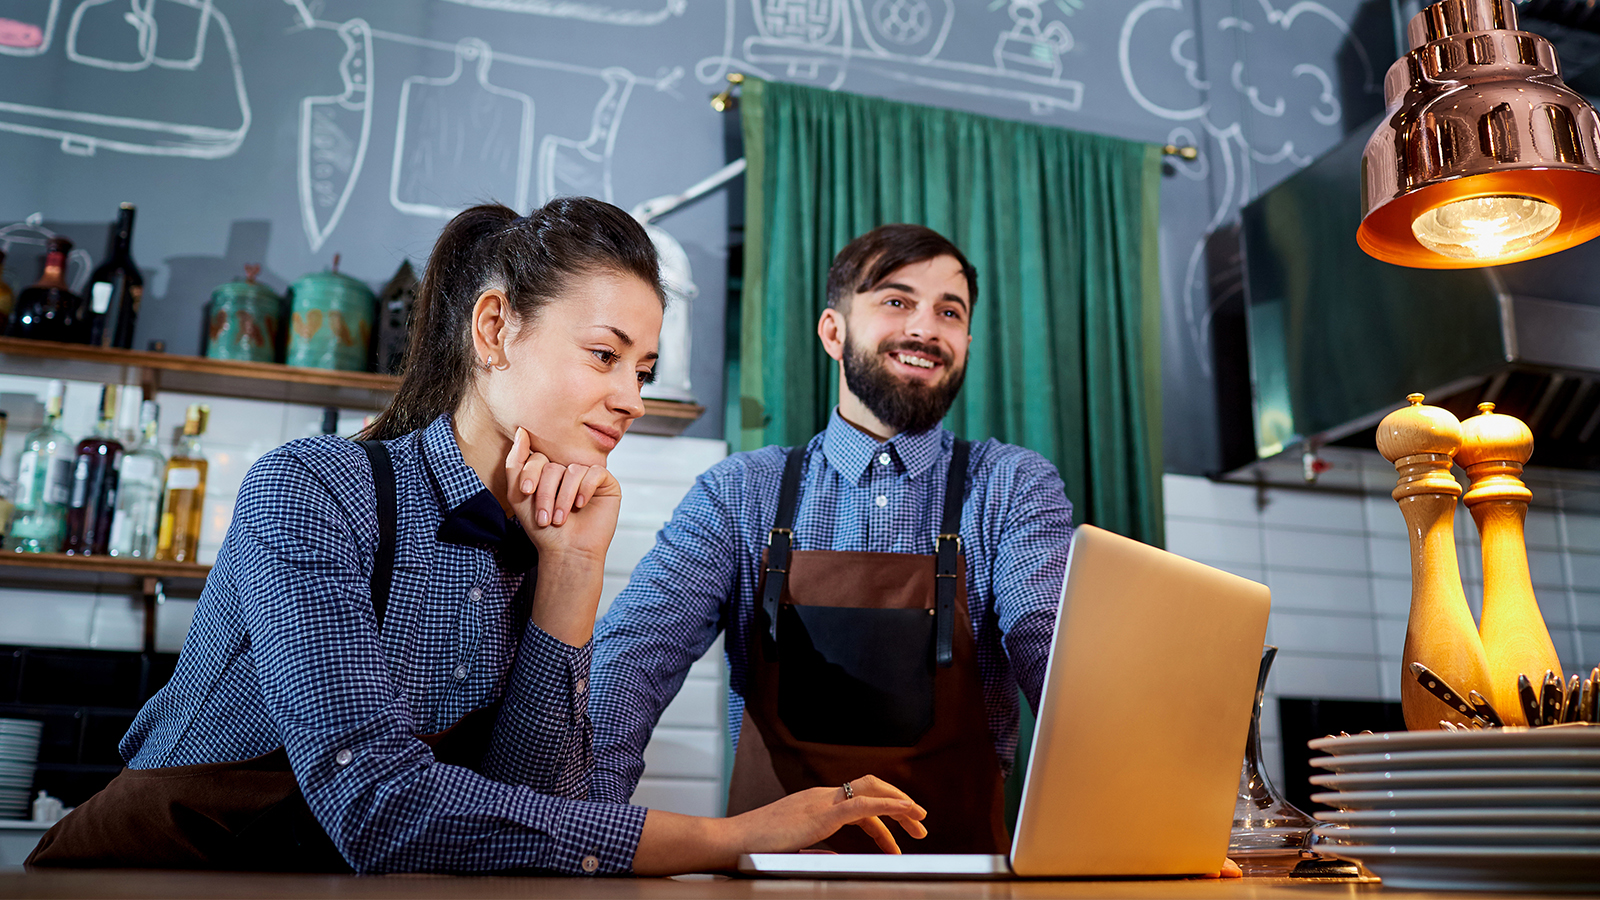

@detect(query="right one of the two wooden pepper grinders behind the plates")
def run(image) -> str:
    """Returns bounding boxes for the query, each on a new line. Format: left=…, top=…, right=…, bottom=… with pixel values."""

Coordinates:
left=1456, top=404, right=1562, bottom=725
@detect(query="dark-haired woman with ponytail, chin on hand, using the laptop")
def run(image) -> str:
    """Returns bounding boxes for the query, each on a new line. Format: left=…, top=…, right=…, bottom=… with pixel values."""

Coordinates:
left=29, top=199, right=925, bottom=874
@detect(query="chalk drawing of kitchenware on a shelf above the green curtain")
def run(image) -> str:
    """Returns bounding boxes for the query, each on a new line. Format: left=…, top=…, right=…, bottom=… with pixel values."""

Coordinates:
left=694, top=0, right=1083, bottom=115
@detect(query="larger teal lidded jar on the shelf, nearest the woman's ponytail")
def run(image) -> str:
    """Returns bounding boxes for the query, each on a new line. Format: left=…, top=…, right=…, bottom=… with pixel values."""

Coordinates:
left=283, top=264, right=376, bottom=372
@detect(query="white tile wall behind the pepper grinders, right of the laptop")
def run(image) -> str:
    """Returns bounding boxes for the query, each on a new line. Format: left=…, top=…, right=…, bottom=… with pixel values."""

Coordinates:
left=1163, top=453, right=1600, bottom=780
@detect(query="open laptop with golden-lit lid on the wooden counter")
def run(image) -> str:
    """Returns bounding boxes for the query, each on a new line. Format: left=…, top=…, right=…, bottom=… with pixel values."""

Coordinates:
left=739, top=525, right=1270, bottom=879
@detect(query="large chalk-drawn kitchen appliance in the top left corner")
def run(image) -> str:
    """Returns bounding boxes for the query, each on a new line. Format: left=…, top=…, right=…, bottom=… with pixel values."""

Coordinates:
left=0, top=0, right=250, bottom=159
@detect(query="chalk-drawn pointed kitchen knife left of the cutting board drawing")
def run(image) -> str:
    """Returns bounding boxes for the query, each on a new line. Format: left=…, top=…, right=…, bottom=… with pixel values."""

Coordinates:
left=299, top=19, right=373, bottom=253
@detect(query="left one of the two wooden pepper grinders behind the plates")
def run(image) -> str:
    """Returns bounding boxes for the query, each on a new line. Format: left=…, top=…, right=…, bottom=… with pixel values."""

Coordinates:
left=1378, top=394, right=1490, bottom=730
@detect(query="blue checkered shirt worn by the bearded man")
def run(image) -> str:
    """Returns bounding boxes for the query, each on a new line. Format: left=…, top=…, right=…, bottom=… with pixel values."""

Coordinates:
left=589, top=410, right=1072, bottom=802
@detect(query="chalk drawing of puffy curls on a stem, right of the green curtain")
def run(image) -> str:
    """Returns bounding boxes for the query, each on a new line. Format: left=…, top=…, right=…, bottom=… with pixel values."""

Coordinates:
left=1117, top=0, right=1378, bottom=376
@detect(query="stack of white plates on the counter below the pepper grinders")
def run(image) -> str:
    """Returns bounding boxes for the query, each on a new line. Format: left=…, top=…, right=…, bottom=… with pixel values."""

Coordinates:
left=1310, top=725, right=1600, bottom=892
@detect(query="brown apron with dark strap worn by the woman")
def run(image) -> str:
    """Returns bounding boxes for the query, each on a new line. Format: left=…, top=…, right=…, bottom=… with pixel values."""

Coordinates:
left=26, top=440, right=499, bottom=871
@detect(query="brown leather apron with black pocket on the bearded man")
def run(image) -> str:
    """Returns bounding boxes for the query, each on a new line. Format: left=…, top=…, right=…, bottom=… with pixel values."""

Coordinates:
left=728, top=440, right=1010, bottom=854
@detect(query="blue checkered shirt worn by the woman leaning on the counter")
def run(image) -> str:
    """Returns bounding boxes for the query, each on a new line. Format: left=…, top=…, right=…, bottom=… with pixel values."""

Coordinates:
left=122, top=416, right=645, bottom=874
